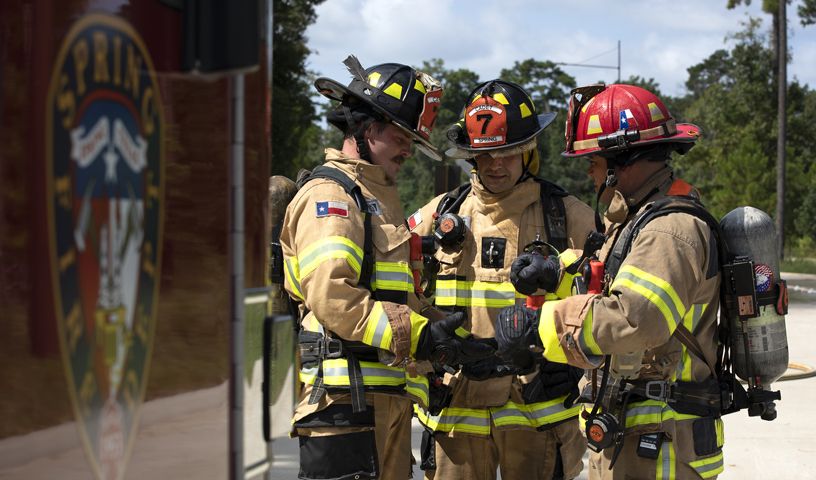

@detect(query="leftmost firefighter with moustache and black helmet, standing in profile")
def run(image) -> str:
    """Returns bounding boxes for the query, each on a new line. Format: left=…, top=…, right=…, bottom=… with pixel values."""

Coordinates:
left=280, top=56, right=493, bottom=479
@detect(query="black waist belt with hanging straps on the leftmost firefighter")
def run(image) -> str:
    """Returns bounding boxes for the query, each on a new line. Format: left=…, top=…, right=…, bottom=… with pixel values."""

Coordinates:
left=298, top=331, right=378, bottom=413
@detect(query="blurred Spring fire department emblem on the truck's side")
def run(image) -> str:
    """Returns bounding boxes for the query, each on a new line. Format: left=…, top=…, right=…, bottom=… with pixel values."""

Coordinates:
left=46, top=15, right=164, bottom=480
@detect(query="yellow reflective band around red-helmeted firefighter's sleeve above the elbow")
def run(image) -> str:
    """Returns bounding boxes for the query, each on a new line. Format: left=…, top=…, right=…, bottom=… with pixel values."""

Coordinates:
left=612, top=265, right=686, bottom=334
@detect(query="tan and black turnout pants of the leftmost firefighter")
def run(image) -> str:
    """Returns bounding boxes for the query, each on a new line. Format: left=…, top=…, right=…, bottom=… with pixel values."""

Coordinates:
left=295, top=394, right=413, bottom=480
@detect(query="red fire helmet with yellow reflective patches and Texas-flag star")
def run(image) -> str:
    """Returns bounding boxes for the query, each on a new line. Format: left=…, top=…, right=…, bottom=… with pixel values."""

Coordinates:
left=561, top=84, right=700, bottom=157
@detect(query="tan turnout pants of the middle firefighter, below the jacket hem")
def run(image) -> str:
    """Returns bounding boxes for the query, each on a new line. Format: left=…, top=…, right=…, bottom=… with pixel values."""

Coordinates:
left=425, top=418, right=586, bottom=480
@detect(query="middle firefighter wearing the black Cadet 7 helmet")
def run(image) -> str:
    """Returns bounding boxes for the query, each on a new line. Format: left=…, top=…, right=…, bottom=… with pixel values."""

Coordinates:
left=408, top=80, right=594, bottom=480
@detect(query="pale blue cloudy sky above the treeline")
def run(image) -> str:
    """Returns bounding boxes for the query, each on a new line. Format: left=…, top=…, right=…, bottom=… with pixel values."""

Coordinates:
left=306, top=0, right=816, bottom=95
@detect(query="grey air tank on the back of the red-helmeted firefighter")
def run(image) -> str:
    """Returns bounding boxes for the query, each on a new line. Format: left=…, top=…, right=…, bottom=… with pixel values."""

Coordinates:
left=720, top=207, right=788, bottom=388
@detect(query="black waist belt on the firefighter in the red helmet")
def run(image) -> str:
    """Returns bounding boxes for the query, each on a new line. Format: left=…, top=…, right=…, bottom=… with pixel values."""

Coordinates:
left=626, top=380, right=722, bottom=416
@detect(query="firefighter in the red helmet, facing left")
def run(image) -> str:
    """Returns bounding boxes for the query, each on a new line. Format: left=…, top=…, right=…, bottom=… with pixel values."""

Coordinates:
left=499, top=85, right=723, bottom=479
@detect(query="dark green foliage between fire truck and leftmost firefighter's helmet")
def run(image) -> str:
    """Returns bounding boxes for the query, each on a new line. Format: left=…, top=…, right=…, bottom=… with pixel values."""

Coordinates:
left=270, top=0, right=323, bottom=178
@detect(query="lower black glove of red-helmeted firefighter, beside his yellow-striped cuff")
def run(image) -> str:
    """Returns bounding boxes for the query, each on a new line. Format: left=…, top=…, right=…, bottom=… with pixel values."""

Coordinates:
left=495, top=305, right=543, bottom=375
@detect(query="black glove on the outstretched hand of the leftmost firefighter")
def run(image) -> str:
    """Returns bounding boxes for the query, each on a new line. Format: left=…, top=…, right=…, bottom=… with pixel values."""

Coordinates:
left=416, top=312, right=495, bottom=368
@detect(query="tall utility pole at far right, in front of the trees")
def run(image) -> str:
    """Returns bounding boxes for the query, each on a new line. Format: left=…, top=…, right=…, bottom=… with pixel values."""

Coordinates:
left=776, top=0, right=788, bottom=259
